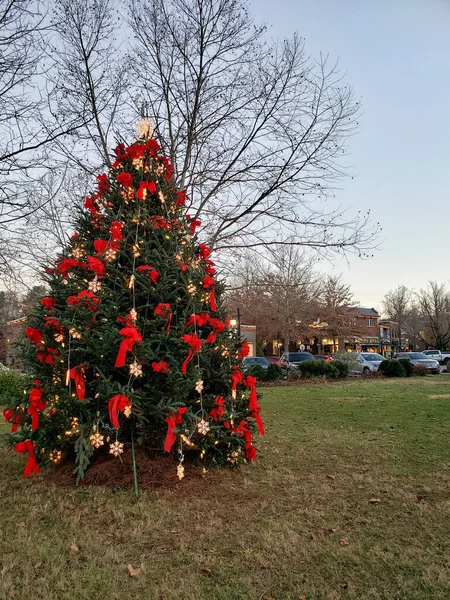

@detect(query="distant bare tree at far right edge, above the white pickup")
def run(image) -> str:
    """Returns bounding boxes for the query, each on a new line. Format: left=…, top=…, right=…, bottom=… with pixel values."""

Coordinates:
left=417, top=281, right=450, bottom=350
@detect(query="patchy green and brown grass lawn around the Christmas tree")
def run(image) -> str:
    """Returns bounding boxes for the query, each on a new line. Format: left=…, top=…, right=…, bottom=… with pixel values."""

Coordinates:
left=0, top=375, right=450, bottom=600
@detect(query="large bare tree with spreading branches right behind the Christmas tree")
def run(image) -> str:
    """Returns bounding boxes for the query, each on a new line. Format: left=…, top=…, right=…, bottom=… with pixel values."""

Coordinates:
left=130, top=0, right=377, bottom=254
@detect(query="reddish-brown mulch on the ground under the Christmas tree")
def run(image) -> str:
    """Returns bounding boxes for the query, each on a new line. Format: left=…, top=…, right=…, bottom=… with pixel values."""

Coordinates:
left=44, top=446, right=203, bottom=489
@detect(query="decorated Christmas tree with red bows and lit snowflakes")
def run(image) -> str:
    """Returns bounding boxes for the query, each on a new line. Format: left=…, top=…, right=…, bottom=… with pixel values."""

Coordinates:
left=4, top=120, right=264, bottom=480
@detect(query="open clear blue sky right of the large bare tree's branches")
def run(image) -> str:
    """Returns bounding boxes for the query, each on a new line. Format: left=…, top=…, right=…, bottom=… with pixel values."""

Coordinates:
left=250, top=0, right=450, bottom=308
